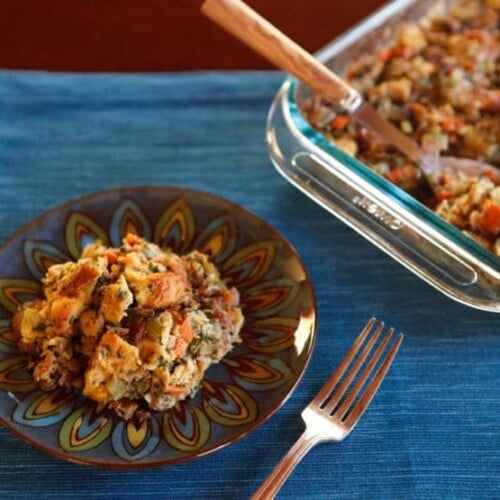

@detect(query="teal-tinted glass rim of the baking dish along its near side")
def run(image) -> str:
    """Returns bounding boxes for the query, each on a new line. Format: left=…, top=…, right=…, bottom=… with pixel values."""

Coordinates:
left=285, top=76, right=500, bottom=269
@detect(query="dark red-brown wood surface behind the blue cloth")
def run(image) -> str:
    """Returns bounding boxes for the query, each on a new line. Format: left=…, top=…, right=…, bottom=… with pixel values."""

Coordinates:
left=0, top=0, right=384, bottom=71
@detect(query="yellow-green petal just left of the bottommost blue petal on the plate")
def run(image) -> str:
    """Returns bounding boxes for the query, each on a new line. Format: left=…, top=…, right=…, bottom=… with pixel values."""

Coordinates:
left=59, top=406, right=113, bottom=452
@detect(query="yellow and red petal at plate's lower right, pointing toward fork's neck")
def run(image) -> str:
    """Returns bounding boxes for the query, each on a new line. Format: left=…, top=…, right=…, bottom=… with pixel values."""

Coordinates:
left=202, top=381, right=258, bottom=427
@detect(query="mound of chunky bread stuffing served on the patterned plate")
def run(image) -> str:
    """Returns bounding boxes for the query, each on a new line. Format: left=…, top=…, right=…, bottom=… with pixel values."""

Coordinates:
left=13, top=234, right=244, bottom=420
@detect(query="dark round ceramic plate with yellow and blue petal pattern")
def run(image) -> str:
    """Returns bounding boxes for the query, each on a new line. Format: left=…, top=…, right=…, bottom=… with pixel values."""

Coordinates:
left=0, top=187, right=316, bottom=468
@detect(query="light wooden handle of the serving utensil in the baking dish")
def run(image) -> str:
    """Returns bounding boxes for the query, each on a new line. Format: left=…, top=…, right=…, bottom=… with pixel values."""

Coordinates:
left=201, top=0, right=350, bottom=103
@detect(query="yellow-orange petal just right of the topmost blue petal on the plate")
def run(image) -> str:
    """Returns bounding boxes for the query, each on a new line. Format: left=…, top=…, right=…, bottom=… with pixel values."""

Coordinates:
left=154, top=198, right=196, bottom=252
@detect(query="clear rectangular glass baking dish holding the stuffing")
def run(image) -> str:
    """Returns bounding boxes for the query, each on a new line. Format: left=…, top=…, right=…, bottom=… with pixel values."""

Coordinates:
left=266, top=0, right=500, bottom=312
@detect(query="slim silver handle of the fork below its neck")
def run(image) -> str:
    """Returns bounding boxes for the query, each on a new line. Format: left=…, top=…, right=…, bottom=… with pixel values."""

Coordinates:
left=251, top=429, right=321, bottom=500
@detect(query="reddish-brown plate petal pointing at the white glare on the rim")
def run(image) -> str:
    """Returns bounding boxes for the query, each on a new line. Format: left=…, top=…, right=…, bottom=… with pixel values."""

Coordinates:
left=240, top=316, right=299, bottom=354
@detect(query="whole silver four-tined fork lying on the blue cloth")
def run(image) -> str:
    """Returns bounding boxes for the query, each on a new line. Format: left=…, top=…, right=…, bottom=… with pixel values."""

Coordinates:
left=252, top=318, right=403, bottom=500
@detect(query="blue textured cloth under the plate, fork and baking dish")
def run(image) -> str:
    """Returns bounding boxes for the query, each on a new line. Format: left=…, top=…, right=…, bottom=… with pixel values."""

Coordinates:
left=0, top=71, right=500, bottom=499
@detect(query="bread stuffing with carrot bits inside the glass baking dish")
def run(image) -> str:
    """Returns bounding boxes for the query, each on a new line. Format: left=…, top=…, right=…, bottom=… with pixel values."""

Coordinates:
left=303, top=0, right=500, bottom=255
